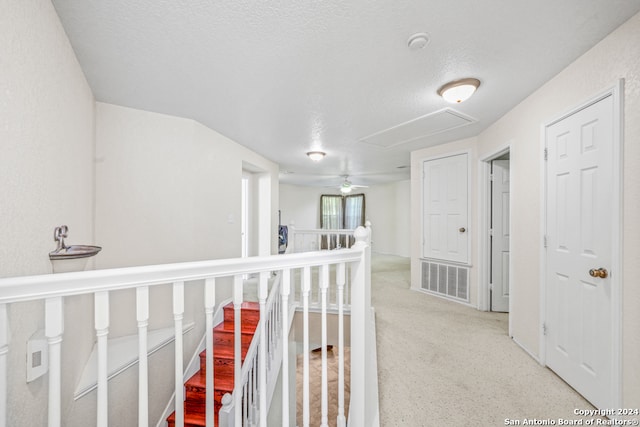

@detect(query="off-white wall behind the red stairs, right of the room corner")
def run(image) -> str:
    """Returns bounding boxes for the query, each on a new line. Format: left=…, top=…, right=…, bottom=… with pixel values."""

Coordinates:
left=94, top=102, right=278, bottom=425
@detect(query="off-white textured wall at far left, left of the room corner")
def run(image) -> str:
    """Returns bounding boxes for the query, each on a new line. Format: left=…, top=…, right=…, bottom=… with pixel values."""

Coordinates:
left=0, top=0, right=94, bottom=427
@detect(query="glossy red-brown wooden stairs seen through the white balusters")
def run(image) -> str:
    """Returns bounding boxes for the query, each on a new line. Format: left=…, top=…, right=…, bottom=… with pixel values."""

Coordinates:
left=167, top=302, right=260, bottom=427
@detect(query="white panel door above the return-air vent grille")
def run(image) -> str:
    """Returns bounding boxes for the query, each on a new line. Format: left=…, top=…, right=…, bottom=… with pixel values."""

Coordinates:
left=422, top=153, right=469, bottom=264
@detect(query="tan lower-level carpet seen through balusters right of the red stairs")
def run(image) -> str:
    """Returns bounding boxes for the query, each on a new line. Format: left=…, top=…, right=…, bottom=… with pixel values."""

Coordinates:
left=296, top=346, right=350, bottom=427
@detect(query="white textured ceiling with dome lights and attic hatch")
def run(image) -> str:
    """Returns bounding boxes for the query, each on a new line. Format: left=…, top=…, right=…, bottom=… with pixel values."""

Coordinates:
left=53, top=0, right=640, bottom=185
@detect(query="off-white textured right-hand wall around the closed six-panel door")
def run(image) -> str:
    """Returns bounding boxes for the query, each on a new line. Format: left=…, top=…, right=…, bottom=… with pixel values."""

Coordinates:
left=412, top=11, right=640, bottom=407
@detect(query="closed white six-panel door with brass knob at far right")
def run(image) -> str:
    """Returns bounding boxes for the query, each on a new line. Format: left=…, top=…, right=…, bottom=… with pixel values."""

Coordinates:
left=544, top=95, right=616, bottom=408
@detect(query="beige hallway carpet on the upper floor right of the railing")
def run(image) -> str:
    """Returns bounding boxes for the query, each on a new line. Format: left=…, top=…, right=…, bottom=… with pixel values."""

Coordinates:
left=372, top=255, right=593, bottom=427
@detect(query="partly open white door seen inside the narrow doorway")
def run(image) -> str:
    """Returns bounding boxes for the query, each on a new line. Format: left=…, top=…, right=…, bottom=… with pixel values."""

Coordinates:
left=491, top=160, right=510, bottom=312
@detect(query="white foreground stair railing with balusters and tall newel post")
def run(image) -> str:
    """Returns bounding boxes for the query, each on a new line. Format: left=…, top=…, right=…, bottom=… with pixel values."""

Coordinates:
left=0, top=228, right=377, bottom=427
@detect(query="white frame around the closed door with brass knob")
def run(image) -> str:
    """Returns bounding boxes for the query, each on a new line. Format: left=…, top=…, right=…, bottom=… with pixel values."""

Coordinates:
left=539, top=79, right=624, bottom=409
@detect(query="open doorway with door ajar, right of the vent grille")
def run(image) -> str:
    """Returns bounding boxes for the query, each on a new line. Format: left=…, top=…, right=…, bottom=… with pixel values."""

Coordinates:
left=478, top=146, right=512, bottom=336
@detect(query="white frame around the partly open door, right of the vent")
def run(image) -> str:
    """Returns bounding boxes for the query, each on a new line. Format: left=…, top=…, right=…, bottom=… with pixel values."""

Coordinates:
left=478, top=145, right=513, bottom=337
